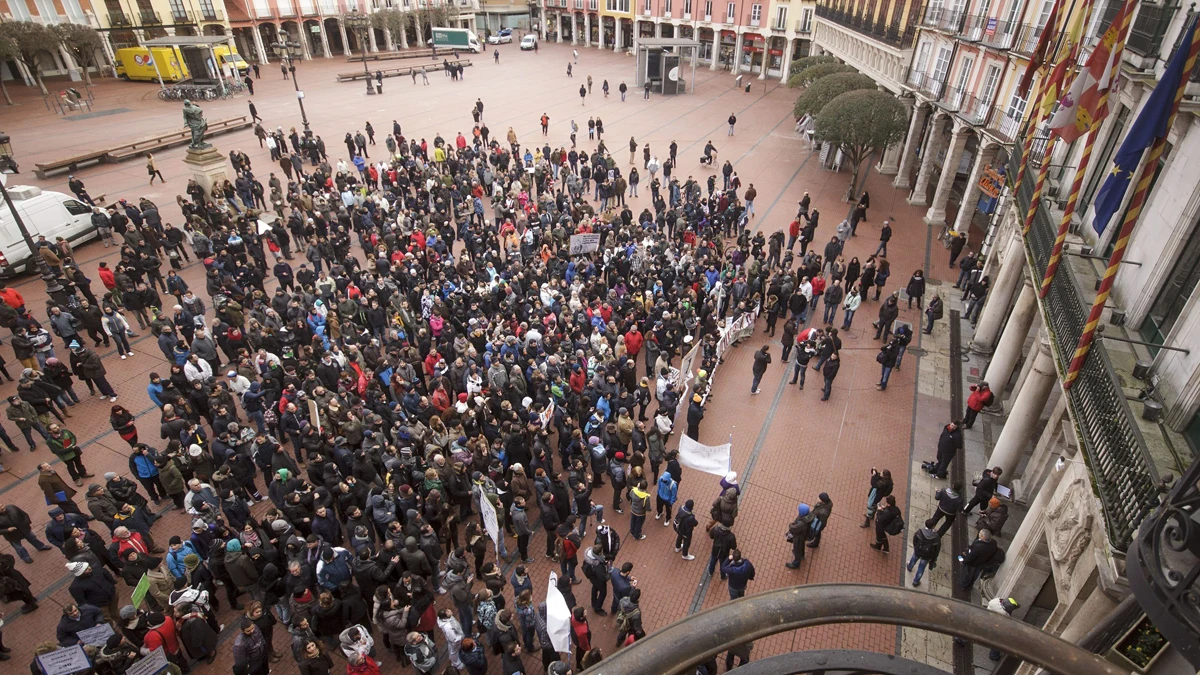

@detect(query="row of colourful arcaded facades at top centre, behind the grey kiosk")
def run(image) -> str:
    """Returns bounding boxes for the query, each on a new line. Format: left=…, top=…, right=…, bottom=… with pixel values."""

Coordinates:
left=542, top=0, right=815, bottom=80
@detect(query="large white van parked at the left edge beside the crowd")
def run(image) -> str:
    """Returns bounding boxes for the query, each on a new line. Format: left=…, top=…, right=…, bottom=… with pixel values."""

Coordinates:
left=0, top=185, right=96, bottom=277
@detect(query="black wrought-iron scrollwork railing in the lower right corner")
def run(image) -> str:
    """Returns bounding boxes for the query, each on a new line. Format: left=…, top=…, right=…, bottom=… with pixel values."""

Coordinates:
left=1126, top=449, right=1200, bottom=668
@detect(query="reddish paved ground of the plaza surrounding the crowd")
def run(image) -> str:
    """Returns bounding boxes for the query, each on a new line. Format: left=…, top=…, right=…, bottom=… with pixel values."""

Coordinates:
left=0, top=44, right=974, bottom=674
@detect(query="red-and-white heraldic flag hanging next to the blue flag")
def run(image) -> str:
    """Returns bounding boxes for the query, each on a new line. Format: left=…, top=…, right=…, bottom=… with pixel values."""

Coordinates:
left=1050, top=2, right=1133, bottom=143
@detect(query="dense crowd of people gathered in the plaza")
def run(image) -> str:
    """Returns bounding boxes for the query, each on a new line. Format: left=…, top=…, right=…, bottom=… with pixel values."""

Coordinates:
left=0, top=52, right=979, bottom=675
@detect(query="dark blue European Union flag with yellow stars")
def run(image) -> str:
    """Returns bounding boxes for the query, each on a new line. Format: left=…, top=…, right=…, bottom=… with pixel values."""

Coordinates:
left=1092, top=17, right=1200, bottom=234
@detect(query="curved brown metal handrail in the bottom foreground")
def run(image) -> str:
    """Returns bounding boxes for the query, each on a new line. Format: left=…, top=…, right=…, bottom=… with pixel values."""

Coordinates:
left=584, top=584, right=1127, bottom=675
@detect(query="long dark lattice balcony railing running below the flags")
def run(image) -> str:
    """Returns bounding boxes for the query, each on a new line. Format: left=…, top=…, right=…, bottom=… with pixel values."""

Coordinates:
left=1008, top=136, right=1158, bottom=551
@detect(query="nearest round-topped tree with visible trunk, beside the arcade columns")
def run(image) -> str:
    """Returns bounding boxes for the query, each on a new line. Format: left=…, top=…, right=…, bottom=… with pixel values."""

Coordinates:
left=814, top=89, right=908, bottom=199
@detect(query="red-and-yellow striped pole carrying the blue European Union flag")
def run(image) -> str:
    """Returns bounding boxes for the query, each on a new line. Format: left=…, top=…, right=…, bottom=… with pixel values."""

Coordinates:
left=1062, top=20, right=1200, bottom=389
